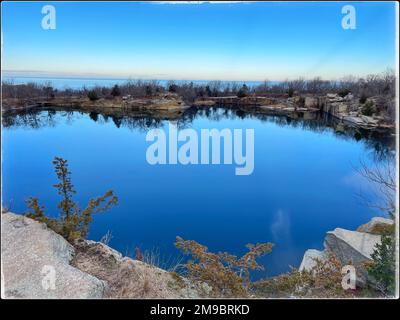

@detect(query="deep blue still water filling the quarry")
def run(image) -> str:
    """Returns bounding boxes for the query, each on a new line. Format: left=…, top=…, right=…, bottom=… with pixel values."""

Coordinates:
left=2, top=110, right=394, bottom=277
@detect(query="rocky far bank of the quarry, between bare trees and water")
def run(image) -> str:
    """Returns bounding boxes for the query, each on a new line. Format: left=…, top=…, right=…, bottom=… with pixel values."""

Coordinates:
left=2, top=93, right=395, bottom=131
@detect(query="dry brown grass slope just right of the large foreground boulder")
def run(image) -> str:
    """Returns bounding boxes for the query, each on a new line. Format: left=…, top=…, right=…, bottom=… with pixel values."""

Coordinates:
left=71, top=240, right=203, bottom=299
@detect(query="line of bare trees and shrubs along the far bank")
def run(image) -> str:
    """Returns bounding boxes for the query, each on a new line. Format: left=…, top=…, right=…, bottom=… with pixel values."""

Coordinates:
left=2, top=69, right=396, bottom=102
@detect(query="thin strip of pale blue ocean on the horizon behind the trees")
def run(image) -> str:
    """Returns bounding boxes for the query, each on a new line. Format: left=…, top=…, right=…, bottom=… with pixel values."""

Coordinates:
left=2, top=75, right=278, bottom=90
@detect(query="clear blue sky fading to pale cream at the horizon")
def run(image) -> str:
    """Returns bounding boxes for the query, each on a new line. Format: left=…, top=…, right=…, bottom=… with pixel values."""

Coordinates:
left=2, top=2, right=397, bottom=81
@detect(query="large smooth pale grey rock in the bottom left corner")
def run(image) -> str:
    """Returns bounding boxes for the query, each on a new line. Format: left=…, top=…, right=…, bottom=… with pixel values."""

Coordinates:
left=1, top=213, right=105, bottom=299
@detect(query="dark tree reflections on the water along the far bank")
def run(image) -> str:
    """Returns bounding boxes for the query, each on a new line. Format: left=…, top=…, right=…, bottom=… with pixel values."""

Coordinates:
left=2, top=107, right=396, bottom=161
